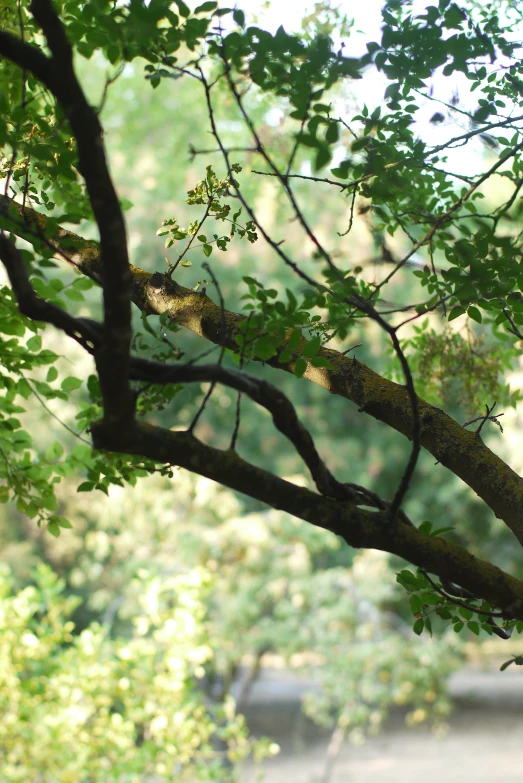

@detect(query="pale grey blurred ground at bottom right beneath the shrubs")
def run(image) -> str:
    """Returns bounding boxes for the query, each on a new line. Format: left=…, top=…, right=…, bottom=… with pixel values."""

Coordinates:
left=242, top=668, right=523, bottom=783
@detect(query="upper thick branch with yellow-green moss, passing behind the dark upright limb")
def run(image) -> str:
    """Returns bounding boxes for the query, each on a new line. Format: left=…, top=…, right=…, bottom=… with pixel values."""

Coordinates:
left=4, top=197, right=523, bottom=543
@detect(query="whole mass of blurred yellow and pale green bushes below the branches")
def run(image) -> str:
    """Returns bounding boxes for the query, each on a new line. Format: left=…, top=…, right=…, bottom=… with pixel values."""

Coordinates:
left=0, top=475, right=461, bottom=781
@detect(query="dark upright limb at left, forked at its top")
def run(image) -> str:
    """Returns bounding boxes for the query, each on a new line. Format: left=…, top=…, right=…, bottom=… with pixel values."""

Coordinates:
left=0, top=0, right=133, bottom=421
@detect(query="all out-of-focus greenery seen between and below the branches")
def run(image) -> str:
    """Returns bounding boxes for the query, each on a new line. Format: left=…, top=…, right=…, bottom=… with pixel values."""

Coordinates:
left=0, top=4, right=523, bottom=783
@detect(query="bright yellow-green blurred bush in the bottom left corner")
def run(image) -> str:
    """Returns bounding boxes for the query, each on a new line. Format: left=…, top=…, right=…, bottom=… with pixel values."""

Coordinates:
left=0, top=566, right=276, bottom=783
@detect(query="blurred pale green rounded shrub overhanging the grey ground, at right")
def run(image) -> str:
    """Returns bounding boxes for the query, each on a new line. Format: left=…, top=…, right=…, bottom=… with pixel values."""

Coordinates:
left=260, top=552, right=460, bottom=742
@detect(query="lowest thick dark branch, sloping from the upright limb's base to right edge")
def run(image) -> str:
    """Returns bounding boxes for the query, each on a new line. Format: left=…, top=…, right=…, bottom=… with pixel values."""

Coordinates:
left=92, top=422, right=523, bottom=620
